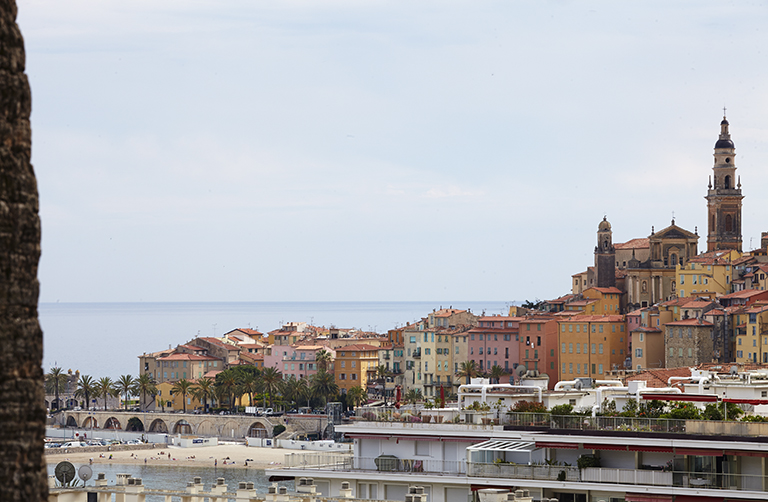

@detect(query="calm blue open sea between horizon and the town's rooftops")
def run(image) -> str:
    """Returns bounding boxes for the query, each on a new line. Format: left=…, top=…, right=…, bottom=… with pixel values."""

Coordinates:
left=39, top=301, right=519, bottom=380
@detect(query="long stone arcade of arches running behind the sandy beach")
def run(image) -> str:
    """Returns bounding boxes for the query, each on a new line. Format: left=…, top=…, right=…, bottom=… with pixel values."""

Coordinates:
left=54, top=410, right=328, bottom=438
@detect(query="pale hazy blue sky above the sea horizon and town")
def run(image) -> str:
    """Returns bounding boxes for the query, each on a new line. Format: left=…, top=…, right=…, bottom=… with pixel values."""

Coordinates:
left=18, top=0, right=768, bottom=302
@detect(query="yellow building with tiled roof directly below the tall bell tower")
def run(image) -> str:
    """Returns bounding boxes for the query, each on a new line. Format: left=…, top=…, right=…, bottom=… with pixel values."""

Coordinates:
left=677, top=249, right=741, bottom=297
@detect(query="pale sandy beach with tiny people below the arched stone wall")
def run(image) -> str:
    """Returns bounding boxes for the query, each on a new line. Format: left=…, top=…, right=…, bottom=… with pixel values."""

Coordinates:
left=45, top=444, right=296, bottom=469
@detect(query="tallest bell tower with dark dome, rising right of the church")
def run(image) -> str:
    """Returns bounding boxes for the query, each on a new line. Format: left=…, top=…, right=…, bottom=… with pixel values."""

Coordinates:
left=705, top=115, right=744, bottom=251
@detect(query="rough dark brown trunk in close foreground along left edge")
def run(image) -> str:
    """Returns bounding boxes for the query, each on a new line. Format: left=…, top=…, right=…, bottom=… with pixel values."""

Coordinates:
left=0, top=0, right=48, bottom=502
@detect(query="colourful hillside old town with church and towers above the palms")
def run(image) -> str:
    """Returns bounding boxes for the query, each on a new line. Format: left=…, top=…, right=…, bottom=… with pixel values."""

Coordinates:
left=51, top=117, right=768, bottom=410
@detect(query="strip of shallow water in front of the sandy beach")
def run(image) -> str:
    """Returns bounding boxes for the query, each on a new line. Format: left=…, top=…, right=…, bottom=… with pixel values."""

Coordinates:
left=48, top=463, right=293, bottom=502
